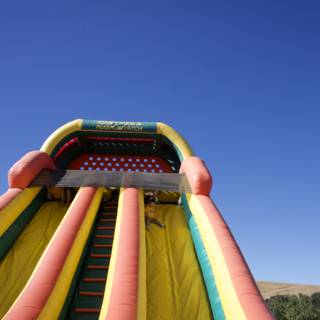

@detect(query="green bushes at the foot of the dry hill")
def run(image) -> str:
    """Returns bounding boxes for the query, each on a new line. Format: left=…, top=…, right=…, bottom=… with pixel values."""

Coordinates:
left=266, top=293, right=320, bottom=320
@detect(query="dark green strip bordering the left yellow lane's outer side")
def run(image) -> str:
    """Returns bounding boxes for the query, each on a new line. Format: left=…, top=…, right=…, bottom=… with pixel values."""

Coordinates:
left=0, top=188, right=45, bottom=260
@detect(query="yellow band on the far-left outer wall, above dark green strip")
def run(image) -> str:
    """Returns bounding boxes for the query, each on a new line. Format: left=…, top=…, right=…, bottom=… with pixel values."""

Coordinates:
left=0, top=188, right=41, bottom=236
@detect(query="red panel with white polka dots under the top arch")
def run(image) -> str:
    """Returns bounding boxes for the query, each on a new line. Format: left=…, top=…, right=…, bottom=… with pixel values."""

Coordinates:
left=69, top=154, right=172, bottom=173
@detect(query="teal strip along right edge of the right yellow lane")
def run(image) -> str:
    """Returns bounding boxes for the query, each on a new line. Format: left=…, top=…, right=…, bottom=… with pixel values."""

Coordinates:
left=182, top=193, right=226, bottom=320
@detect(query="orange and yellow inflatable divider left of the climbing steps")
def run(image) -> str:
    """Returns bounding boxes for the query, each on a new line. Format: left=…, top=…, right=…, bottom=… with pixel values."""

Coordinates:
left=4, top=187, right=103, bottom=320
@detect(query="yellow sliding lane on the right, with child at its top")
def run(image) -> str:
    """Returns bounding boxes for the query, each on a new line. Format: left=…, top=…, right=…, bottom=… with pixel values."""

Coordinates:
left=146, top=205, right=211, bottom=320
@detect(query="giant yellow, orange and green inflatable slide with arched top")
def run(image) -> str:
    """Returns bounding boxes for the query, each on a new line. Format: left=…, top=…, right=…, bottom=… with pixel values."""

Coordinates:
left=0, top=120, right=272, bottom=320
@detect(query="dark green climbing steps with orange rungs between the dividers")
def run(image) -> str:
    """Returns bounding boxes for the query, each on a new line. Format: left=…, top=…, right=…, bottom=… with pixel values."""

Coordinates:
left=66, top=202, right=117, bottom=320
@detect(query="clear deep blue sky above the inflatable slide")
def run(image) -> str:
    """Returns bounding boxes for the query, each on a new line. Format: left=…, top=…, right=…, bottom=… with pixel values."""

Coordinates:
left=0, top=0, right=320, bottom=284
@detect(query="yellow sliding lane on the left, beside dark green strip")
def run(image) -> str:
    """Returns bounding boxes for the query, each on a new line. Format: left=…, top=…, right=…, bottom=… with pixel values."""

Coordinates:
left=0, top=202, right=67, bottom=318
